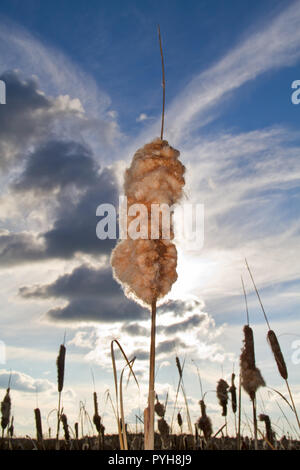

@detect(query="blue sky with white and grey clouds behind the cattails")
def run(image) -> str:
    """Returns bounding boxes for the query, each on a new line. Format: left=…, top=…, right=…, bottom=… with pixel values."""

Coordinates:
left=0, top=0, right=300, bottom=440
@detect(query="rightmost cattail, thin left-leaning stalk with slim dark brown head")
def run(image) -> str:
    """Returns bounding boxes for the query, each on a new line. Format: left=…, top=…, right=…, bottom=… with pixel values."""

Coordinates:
left=245, top=259, right=300, bottom=429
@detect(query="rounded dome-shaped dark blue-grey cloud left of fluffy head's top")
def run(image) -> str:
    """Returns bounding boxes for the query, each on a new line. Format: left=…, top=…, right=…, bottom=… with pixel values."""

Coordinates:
left=13, top=140, right=99, bottom=192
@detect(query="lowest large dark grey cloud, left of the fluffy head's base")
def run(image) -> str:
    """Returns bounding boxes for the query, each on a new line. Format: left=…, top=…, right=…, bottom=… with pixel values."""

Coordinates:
left=19, top=265, right=148, bottom=322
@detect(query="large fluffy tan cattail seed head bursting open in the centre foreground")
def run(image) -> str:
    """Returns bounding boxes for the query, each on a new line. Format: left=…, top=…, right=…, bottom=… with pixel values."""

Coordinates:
left=111, top=139, right=185, bottom=306
